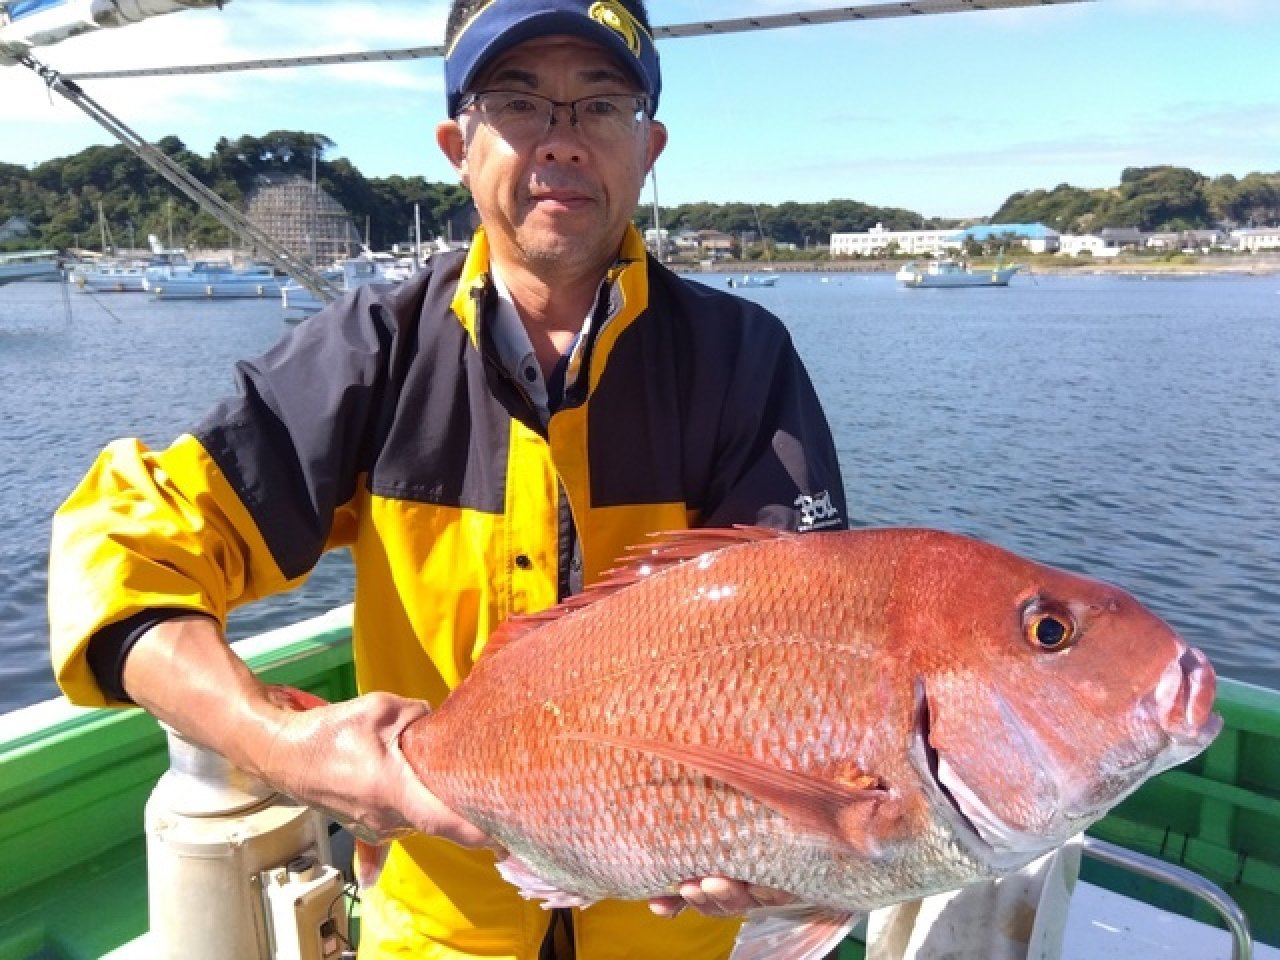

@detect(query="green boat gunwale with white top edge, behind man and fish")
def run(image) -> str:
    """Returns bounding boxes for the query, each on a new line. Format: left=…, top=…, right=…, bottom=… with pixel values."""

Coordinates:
left=0, top=607, right=1280, bottom=960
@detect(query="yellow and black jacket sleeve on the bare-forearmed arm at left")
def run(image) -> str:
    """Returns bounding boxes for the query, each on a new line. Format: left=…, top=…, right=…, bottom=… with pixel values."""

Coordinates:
left=49, top=285, right=392, bottom=705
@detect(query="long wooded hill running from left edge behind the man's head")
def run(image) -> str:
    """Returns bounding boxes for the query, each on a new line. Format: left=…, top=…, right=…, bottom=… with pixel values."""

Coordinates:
left=0, top=131, right=954, bottom=256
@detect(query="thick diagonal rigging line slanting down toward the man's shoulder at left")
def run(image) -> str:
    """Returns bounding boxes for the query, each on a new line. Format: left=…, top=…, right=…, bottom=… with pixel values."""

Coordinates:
left=18, top=54, right=342, bottom=303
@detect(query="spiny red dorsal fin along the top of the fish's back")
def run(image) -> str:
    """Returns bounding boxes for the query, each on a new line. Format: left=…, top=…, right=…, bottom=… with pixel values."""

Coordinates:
left=481, top=526, right=797, bottom=657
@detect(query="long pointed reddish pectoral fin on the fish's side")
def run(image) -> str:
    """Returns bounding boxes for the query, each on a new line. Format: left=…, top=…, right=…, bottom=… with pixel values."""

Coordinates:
left=562, top=733, right=892, bottom=859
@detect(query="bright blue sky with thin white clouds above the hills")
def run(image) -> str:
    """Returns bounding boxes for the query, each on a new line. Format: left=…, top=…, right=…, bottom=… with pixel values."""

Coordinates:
left=0, top=0, right=1280, bottom=218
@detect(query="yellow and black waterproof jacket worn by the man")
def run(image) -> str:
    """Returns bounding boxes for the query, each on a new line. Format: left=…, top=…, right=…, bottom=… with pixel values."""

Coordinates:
left=50, top=230, right=845, bottom=960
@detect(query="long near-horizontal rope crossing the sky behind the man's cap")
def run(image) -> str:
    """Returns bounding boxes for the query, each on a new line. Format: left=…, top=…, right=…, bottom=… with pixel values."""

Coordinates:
left=67, top=0, right=1094, bottom=79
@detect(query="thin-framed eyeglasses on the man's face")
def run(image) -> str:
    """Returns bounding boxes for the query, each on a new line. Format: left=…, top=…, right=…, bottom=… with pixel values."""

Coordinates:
left=458, top=90, right=649, bottom=143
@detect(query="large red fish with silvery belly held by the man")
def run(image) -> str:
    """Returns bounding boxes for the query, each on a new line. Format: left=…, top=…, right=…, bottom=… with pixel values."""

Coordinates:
left=293, top=529, right=1221, bottom=960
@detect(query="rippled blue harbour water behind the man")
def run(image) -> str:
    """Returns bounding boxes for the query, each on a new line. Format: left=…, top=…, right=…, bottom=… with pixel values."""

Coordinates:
left=0, top=273, right=1280, bottom=709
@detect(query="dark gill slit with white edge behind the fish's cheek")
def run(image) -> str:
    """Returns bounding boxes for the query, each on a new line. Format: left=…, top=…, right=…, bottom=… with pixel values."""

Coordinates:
left=909, top=680, right=1046, bottom=870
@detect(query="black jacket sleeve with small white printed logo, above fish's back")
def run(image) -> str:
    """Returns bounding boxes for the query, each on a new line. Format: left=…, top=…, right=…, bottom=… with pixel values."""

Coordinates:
left=700, top=311, right=847, bottom=532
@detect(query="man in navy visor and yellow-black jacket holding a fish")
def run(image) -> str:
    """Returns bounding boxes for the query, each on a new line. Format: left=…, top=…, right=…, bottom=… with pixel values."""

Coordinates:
left=50, top=0, right=845, bottom=960
